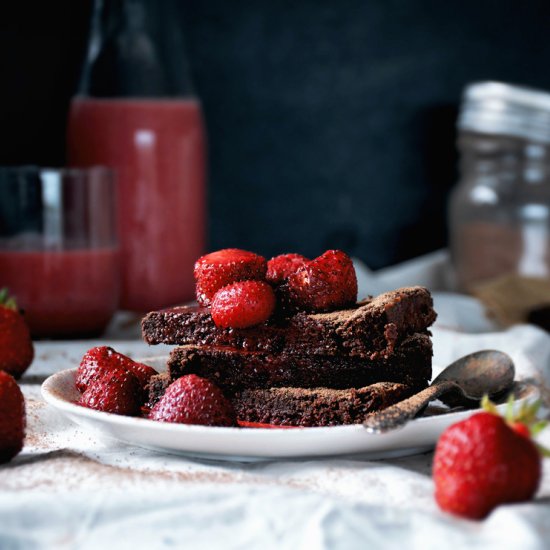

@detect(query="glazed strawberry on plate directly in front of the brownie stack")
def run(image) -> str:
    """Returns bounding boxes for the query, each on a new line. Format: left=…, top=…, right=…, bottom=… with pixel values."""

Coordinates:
left=149, top=374, right=236, bottom=426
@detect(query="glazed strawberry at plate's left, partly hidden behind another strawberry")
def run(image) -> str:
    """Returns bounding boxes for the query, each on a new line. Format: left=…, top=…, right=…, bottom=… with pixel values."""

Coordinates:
left=76, top=346, right=158, bottom=392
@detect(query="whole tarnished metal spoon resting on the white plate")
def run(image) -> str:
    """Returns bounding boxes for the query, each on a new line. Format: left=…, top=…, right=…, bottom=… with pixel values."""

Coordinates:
left=363, top=350, right=515, bottom=433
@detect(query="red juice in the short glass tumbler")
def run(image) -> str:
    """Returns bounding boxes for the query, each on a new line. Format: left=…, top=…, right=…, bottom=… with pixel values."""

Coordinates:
left=0, top=248, right=119, bottom=337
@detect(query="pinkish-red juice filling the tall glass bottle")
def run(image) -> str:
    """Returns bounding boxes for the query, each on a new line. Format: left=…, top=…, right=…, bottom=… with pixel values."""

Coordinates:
left=68, top=97, right=206, bottom=311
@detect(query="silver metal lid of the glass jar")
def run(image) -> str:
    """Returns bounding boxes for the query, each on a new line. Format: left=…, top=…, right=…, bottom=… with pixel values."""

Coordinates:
left=458, top=82, right=550, bottom=143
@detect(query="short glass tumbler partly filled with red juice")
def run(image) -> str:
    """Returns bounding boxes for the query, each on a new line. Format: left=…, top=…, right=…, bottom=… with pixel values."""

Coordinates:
left=0, top=166, right=119, bottom=338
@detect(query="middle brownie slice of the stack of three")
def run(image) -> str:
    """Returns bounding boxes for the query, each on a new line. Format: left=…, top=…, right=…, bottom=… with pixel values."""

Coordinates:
left=168, top=333, right=432, bottom=394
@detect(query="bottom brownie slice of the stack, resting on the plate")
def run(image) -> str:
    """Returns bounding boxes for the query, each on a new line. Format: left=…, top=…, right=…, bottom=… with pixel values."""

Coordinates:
left=233, top=382, right=414, bottom=426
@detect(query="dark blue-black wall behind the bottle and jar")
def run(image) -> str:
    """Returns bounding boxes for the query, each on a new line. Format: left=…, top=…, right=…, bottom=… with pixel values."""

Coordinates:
left=0, top=0, right=550, bottom=268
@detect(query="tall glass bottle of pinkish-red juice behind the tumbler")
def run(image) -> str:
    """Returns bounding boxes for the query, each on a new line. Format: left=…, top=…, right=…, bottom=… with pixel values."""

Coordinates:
left=67, top=0, right=206, bottom=312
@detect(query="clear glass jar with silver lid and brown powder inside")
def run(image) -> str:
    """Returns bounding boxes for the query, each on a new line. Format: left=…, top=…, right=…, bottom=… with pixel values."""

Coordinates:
left=449, top=82, right=550, bottom=324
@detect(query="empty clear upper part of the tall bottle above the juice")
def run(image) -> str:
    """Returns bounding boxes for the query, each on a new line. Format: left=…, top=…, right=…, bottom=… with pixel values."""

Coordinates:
left=79, top=0, right=194, bottom=98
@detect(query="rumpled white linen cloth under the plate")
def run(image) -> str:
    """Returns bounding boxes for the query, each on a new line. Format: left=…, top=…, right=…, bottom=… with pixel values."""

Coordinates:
left=0, top=253, right=550, bottom=550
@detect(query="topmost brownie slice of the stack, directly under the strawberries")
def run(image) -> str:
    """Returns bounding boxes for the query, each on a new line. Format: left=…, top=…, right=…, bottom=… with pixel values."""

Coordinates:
left=142, top=287, right=436, bottom=358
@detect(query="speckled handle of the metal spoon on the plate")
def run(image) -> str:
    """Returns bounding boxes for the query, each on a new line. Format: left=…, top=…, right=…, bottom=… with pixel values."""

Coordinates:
left=363, top=380, right=457, bottom=433
